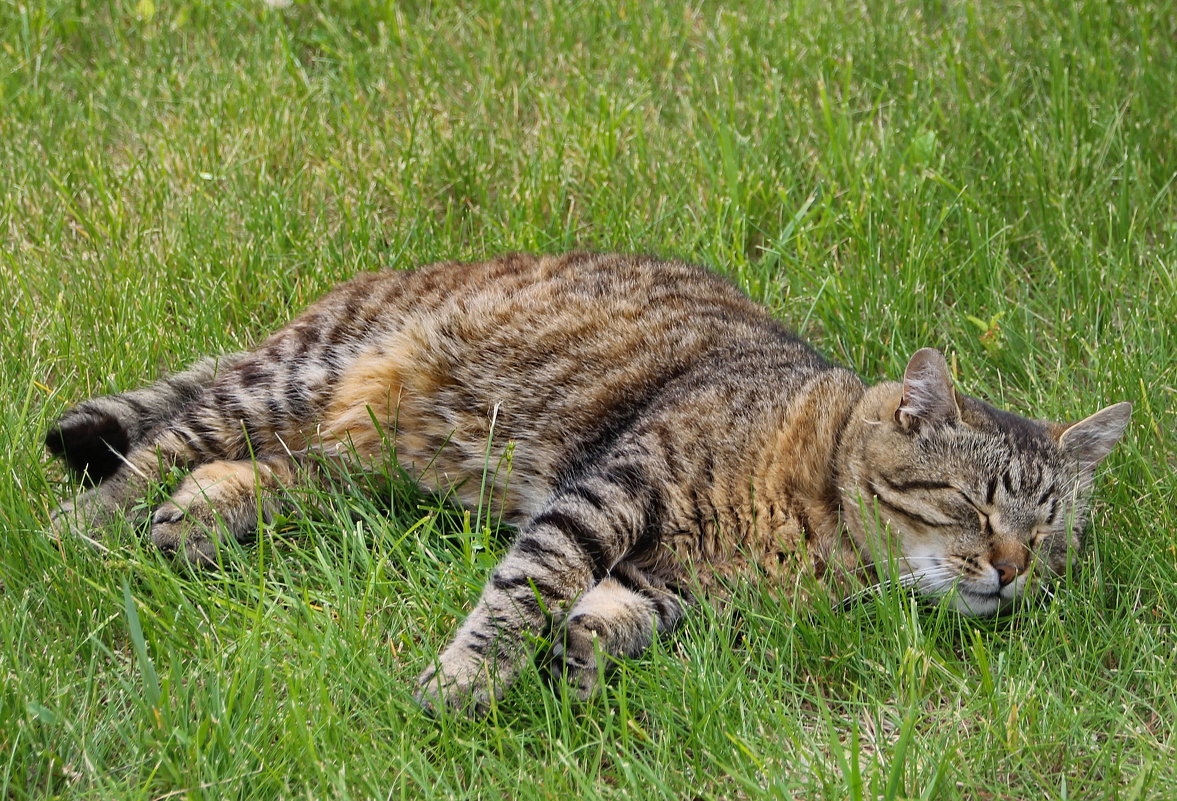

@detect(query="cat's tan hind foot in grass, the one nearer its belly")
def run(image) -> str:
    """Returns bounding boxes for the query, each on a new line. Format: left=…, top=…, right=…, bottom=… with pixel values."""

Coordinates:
left=151, top=458, right=298, bottom=566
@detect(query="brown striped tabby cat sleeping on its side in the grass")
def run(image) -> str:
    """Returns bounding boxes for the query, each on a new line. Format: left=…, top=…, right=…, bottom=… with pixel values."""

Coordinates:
left=46, top=253, right=1131, bottom=712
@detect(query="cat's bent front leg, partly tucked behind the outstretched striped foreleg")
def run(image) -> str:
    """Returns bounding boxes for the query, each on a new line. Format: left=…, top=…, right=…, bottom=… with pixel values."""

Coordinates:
left=551, top=563, right=689, bottom=699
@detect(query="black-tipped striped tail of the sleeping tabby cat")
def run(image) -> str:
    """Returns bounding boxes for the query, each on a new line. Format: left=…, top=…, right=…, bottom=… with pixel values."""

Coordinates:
left=45, top=353, right=245, bottom=483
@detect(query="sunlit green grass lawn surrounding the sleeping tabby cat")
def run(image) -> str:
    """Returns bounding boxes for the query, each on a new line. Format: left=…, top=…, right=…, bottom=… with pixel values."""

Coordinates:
left=0, top=0, right=1177, bottom=801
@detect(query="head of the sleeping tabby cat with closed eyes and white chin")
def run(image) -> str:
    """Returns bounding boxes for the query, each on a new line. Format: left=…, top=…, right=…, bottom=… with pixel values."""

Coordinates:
left=838, top=348, right=1132, bottom=615
